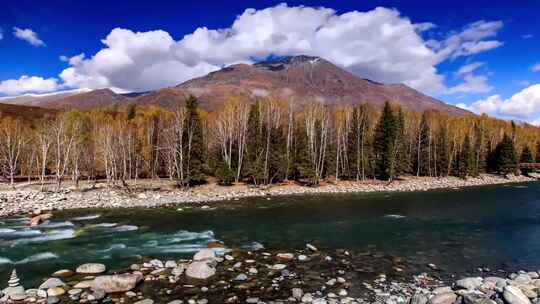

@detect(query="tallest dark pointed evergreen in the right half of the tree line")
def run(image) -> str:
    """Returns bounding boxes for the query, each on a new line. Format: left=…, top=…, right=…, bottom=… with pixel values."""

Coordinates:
left=374, top=102, right=397, bottom=180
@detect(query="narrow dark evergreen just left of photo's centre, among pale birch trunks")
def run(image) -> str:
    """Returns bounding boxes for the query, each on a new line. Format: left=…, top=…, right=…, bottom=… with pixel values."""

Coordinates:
left=244, top=102, right=264, bottom=185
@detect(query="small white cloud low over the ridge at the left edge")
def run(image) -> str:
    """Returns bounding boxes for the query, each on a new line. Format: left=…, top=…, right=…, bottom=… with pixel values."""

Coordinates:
left=0, top=75, right=60, bottom=95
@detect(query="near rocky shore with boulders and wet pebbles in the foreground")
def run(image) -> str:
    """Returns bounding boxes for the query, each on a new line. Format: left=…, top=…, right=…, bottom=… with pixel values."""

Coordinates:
left=0, top=243, right=540, bottom=304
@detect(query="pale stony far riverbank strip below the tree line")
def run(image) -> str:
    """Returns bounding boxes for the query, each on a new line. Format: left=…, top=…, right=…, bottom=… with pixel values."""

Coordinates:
left=0, top=174, right=537, bottom=218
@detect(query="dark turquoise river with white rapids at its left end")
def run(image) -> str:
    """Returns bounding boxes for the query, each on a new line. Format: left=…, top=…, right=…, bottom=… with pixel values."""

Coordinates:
left=0, top=183, right=540, bottom=286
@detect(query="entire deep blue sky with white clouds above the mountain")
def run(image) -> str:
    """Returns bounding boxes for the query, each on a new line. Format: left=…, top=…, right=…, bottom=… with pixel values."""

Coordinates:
left=0, top=0, right=540, bottom=122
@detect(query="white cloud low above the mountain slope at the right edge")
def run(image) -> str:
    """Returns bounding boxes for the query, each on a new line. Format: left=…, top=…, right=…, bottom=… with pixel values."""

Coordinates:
left=458, top=84, right=540, bottom=122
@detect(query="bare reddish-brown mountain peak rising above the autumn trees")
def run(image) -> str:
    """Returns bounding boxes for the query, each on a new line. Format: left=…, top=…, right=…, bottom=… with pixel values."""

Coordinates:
left=136, top=56, right=469, bottom=115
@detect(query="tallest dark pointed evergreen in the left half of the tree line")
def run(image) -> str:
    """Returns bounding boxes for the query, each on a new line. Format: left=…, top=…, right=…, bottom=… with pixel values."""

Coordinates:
left=183, top=95, right=206, bottom=186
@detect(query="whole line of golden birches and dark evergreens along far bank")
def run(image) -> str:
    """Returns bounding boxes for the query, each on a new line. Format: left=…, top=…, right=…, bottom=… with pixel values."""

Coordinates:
left=0, top=96, right=540, bottom=189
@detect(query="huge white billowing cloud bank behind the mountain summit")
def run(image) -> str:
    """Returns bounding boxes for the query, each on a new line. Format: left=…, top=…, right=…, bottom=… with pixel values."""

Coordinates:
left=60, top=4, right=503, bottom=93
